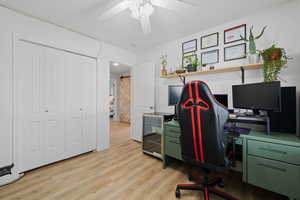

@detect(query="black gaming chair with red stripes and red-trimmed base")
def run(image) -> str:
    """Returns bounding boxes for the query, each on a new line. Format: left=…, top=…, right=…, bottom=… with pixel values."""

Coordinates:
left=176, top=81, right=237, bottom=200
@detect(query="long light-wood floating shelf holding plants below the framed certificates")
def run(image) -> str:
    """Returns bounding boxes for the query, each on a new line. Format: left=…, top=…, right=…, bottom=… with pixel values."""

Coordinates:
left=160, top=64, right=263, bottom=78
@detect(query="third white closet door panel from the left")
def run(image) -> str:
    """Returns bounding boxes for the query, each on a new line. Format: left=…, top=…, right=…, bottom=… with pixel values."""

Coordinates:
left=65, top=54, right=84, bottom=157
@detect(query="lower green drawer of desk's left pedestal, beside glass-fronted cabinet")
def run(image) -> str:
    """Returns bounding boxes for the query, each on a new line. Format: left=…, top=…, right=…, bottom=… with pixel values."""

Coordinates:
left=165, top=136, right=182, bottom=160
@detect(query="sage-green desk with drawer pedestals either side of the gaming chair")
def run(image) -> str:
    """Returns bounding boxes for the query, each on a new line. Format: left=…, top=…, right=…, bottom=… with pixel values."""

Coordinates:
left=163, top=121, right=300, bottom=200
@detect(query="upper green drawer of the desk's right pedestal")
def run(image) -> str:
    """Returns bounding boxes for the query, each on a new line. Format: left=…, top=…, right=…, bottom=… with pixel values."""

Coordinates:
left=248, top=140, right=300, bottom=165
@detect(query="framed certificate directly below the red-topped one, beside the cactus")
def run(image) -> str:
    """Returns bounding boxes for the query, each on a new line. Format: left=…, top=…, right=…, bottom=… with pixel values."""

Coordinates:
left=224, top=43, right=247, bottom=61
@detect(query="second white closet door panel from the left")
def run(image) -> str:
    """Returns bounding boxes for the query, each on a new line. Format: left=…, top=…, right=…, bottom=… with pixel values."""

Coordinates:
left=41, top=47, right=66, bottom=163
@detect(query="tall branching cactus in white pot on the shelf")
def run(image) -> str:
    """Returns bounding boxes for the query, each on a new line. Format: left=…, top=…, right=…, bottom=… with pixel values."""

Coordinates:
left=241, top=26, right=267, bottom=64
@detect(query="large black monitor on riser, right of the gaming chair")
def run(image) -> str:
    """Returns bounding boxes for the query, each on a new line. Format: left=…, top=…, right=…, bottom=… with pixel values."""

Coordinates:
left=232, top=81, right=281, bottom=113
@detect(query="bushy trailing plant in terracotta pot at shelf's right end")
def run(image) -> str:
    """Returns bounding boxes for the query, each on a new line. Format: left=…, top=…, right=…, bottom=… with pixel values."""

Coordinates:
left=260, top=44, right=291, bottom=82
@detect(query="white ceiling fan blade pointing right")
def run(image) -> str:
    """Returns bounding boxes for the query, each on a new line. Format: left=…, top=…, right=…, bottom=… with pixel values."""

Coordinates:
left=151, top=0, right=195, bottom=12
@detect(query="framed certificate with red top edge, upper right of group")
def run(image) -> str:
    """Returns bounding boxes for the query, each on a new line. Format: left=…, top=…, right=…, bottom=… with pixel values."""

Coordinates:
left=224, top=24, right=247, bottom=44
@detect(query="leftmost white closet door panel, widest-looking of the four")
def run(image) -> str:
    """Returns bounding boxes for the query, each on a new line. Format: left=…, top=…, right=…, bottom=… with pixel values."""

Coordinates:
left=15, top=41, right=44, bottom=172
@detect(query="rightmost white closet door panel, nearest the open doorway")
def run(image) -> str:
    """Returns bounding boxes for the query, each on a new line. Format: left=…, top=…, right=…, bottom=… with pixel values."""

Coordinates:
left=82, top=57, right=97, bottom=152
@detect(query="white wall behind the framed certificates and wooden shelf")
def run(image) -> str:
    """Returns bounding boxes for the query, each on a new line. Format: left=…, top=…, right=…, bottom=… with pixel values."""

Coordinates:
left=138, top=1, right=300, bottom=130
